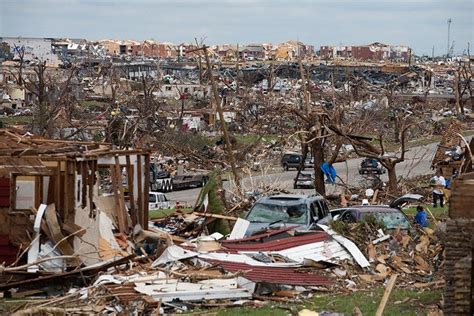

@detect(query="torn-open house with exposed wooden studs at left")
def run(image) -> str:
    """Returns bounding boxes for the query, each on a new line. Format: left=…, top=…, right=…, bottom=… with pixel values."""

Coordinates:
left=0, top=129, right=150, bottom=271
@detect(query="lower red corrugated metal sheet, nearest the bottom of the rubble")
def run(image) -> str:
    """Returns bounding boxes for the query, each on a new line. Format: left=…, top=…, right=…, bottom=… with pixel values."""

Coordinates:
left=212, top=260, right=332, bottom=286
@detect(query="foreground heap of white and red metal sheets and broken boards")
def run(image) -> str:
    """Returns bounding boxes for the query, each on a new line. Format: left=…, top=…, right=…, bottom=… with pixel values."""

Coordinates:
left=1, top=218, right=369, bottom=313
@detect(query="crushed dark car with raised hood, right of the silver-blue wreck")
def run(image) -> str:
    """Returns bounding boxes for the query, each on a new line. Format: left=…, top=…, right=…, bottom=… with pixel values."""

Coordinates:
left=330, top=194, right=423, bottom=230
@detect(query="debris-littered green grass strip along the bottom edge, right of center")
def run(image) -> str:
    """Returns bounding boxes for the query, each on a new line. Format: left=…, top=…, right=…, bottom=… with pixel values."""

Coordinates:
left=209, top=288, right=442, bottom=316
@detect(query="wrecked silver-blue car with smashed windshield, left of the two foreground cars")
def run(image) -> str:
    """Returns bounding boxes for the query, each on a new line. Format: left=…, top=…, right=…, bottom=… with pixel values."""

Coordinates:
left=245, top=194, right=331, bottom=236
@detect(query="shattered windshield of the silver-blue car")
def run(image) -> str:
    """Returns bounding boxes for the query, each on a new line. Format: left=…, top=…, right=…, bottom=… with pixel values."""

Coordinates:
left=247, top=203, right=308, bottom=224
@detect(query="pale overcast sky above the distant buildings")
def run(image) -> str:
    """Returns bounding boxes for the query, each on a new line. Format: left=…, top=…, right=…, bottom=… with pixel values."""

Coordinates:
left=0, top=0, right=474, bottom=55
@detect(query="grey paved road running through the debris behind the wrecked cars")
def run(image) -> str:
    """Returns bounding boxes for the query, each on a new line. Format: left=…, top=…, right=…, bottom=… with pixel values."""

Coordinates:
left=166, top=142, right=466, bottom=205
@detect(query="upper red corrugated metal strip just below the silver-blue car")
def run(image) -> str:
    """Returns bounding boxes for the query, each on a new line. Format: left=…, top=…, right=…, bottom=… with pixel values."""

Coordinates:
left=222, top=232, right=328, bottom=251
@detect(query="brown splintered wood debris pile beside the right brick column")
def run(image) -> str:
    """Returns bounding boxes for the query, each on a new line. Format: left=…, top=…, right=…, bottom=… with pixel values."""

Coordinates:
left=333, top=220, right=446, bottom=291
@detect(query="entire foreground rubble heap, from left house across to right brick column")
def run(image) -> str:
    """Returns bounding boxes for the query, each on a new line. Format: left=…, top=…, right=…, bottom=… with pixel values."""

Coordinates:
left=0, top=201, right=444, bottom=313
